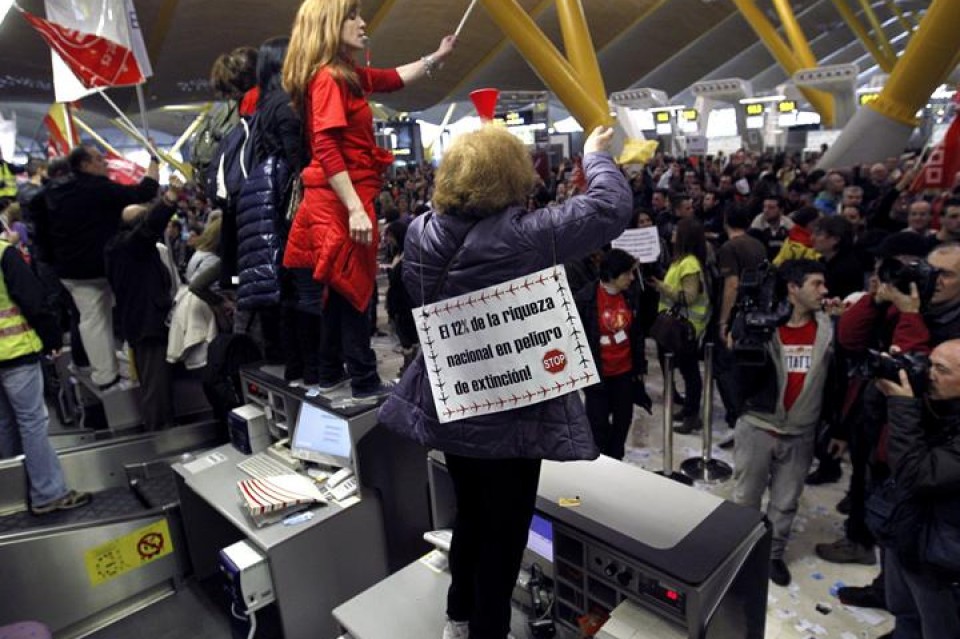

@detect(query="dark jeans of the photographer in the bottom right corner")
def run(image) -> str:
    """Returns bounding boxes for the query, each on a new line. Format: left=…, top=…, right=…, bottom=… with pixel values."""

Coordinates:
left=884, top=552, right=960, bottom=639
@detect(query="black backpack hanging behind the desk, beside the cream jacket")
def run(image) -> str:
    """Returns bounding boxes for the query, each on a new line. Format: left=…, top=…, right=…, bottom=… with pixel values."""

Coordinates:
left=203, top=333, right=263, bottom=424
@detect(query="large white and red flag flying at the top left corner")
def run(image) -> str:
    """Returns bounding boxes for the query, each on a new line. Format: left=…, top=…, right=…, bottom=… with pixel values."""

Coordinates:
left=21, top=0, right=150, bottom=102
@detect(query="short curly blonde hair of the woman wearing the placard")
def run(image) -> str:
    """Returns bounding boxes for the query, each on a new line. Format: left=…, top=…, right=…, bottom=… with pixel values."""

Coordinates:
left=433, top=125, right=537, bottom=217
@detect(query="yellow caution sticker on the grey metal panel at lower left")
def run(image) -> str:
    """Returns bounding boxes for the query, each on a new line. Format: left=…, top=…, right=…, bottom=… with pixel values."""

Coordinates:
left=83, top=519, right=173, bottom=586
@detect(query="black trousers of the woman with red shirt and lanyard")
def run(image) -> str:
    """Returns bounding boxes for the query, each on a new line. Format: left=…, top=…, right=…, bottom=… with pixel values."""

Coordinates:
left=584, top=373, right=633, bottom=459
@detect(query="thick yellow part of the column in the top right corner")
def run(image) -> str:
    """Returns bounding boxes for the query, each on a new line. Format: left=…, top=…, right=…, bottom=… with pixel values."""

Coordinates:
left=866, top=0, right=960, bottom=126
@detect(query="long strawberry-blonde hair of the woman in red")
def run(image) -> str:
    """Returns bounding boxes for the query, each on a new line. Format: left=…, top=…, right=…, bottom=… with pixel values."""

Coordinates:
left=283, top=0, right=363, bottom=111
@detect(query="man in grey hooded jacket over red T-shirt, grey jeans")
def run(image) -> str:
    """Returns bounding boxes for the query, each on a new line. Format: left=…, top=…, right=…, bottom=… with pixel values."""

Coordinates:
left=734, top=260, right=833, bottom=586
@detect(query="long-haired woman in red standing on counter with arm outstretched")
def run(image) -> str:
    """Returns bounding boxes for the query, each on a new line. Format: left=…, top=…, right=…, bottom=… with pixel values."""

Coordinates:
left=283, top=0, right=455, bottom=401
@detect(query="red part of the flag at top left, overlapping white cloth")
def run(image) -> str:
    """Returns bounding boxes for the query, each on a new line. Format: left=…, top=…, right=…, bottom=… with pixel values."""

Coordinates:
left=20, top=11, right=144, bottom=89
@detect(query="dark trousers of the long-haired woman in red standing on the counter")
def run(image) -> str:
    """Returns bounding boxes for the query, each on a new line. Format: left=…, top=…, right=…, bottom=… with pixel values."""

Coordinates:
left=319, top=289, right=380, bottom=392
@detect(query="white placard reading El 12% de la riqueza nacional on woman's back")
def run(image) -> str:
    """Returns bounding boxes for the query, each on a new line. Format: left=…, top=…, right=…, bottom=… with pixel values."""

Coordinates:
left=413, top=265, right=600, bottom=423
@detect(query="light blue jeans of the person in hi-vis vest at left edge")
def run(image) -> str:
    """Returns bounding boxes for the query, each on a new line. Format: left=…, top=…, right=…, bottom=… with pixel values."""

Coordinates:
left=0, top=362, right=67, bottom=506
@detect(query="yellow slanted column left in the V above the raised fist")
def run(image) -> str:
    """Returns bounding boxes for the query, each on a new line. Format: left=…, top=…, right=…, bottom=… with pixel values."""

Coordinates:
left=480, top=0, right=614, bottom=131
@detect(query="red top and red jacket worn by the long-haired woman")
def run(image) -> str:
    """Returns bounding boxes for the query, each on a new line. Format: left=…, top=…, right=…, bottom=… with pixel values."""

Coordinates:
left=283, top=67, right=403, bottom=312
